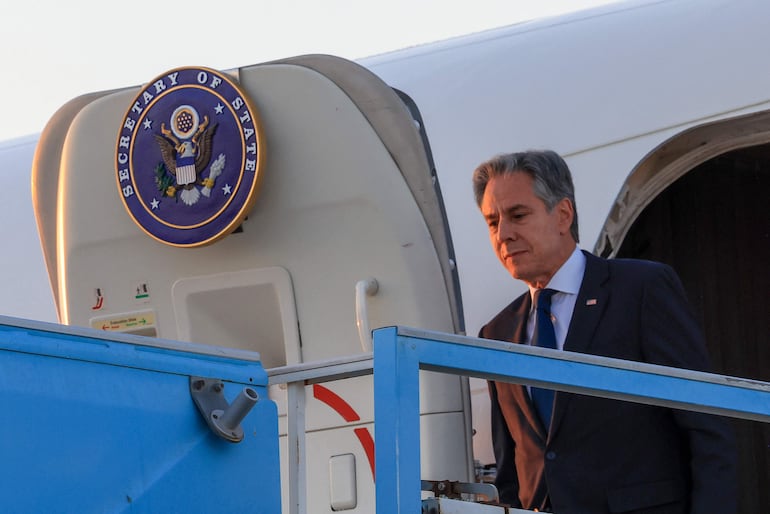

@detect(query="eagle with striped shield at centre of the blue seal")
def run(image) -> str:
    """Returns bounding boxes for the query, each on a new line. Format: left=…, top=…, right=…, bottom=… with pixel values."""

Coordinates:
left=155, top=105, right=225, bottom=205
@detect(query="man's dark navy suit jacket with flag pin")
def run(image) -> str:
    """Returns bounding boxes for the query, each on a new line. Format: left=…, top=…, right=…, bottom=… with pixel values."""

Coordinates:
left=480, top=252, right=737, bottom=514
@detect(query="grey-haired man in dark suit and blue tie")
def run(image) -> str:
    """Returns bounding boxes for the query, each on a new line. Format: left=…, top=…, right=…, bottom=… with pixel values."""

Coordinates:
left=473, top=151, right=737, bottom=514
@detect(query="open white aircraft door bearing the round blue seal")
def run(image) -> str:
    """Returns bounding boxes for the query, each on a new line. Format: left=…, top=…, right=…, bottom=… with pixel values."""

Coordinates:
left=33, top=56, right=473, bottom=513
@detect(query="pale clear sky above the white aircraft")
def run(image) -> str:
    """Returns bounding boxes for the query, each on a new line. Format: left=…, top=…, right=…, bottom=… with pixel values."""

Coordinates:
left=0, top=0, right=615, bottom=141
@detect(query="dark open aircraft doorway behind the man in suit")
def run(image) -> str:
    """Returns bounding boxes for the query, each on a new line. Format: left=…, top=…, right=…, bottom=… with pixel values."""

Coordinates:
left=616, top=144, right=770, bottom=513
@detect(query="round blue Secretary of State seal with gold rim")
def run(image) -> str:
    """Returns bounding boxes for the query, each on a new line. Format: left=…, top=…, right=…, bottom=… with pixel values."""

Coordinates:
left=115, top=67, right=265, bottom=247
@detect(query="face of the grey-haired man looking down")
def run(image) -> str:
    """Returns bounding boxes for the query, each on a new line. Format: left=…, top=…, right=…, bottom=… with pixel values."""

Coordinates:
left=481, top=172, right=575, bottom=288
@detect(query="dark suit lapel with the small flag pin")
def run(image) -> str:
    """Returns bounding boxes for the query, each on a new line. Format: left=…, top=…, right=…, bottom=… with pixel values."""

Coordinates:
left=549, top=252, right=609, bottom=437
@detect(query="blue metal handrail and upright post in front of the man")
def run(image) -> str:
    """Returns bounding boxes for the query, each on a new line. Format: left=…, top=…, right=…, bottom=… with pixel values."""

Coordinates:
left=374, top=327, right=770, bottom=514
